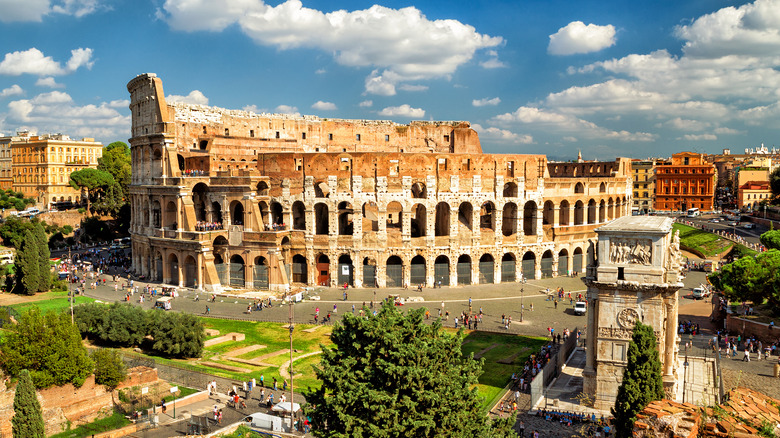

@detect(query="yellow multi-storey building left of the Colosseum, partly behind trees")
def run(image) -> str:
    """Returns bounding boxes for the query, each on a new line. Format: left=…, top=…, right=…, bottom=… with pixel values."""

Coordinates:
left=11, top=132, right=103, bottom=208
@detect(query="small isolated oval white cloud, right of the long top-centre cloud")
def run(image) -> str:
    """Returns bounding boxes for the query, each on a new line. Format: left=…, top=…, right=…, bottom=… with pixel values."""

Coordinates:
left=547, top=21, right=615, bottom=55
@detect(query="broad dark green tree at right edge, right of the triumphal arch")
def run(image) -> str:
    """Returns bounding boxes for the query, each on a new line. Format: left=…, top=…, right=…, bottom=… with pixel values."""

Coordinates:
left=709, top=248, right=780, bottom=308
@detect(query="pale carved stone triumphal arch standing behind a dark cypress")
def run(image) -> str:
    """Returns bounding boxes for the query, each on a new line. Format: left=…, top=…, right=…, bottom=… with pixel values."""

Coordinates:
left=583, top=216, right=683, bottom=409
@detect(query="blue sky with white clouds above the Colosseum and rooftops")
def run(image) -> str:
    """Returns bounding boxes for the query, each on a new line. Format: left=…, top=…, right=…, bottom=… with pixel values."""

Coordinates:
left=0, top=0, right=780, bottom=159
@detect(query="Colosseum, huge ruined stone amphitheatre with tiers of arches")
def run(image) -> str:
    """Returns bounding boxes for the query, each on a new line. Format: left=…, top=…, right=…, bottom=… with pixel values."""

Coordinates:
left=127, top=73, right=632, bottom=291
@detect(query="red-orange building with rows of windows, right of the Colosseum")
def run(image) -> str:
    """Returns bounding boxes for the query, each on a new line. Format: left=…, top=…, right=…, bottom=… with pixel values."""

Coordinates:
left=655, top=152, right=717, bottom=211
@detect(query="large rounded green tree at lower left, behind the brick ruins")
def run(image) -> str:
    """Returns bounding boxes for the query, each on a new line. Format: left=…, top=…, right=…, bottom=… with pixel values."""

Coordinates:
left=0, top=307, right=94, bottom=388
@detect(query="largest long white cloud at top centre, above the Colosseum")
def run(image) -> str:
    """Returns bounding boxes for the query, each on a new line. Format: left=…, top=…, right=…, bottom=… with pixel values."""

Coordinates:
left=158, top=0, right=503, bottom=96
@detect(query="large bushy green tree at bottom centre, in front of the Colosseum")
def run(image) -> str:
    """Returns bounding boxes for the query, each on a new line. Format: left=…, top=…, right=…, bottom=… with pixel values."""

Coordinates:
left=306, top=303, right=500, bottom=437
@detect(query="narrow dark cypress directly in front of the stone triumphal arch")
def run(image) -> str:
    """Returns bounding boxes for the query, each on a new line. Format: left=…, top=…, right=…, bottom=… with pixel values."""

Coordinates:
left=612, top=322, right=671, bottom=438
